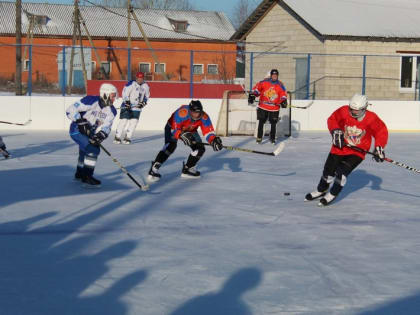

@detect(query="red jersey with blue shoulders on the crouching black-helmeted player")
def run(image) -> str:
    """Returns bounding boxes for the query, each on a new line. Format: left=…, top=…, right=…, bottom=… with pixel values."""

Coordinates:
left=168, top=105, right=216, bottom=143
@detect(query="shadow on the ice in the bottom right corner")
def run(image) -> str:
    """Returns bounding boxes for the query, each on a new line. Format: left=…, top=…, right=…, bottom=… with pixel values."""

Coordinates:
left=358, top=293, right=420, bottom=315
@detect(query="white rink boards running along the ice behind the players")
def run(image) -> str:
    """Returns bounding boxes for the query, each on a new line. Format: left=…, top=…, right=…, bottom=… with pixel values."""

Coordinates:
left=0, top=96, right=420, bottom=132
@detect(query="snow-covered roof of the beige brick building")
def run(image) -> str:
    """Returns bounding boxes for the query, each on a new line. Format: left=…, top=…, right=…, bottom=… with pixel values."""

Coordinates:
left=232, top=0, right=420, bottom=39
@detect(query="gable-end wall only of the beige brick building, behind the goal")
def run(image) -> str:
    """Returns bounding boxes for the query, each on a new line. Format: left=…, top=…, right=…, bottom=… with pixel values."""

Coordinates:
left=246, top=4, right=325, bottom=91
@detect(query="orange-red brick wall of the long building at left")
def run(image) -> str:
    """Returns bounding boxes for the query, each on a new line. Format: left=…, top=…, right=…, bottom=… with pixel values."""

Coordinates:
left=0, top=37, right=236, bottom=89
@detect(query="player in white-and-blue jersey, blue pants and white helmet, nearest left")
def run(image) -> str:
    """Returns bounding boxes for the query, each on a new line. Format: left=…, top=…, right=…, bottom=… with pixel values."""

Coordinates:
left=66, top=83, right=117, bottom=187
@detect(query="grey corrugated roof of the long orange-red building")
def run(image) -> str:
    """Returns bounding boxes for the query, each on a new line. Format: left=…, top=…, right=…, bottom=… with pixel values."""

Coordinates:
left=0, top=2, right=235, bottom=40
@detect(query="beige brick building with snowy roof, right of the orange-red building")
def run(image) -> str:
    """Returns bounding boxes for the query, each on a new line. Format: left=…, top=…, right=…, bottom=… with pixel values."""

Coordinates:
left=231, top=0, right=420, bottom=100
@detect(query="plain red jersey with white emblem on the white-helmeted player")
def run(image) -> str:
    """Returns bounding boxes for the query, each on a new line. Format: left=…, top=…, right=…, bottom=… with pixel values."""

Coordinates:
left=327, top=105, right=388, bottom=159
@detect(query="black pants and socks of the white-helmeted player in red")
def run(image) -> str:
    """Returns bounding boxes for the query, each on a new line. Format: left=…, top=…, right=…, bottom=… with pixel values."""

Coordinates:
left=317, top=153, right=363, bottom=196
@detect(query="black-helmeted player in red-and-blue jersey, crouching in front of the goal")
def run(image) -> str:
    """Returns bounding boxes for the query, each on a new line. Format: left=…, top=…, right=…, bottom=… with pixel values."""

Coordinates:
left=147, top=100, right=223, bottom=182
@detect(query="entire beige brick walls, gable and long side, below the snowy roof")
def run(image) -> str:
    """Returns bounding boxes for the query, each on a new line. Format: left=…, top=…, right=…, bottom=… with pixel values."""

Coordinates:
left=245, top=4, right=420, bottom=100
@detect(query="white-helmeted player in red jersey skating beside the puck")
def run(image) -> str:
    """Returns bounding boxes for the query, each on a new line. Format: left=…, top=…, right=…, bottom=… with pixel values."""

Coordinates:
left=305, top=94, right=388, bottom=206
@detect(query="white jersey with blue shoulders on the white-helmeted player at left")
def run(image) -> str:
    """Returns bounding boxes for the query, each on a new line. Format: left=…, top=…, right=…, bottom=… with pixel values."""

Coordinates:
left=66, top=95, right=117, bottom=135
